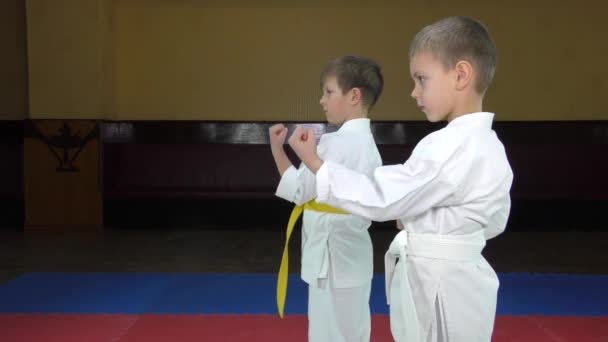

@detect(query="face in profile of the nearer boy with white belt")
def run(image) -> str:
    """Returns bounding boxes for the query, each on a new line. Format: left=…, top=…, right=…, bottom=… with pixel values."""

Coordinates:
left=410, top=52, right=456, bottom=122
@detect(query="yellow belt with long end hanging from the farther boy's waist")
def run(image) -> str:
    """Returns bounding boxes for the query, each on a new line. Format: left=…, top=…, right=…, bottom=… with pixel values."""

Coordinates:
left=277, top=200, right=348, bottom=318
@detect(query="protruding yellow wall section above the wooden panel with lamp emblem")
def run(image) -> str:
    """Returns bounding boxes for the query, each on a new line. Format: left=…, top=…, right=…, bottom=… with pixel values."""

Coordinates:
left=26, top=0, right=113, bottom=119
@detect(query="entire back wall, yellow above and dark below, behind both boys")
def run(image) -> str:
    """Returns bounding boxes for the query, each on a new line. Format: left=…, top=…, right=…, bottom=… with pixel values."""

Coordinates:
left=0, top=0, right=608, bottom=229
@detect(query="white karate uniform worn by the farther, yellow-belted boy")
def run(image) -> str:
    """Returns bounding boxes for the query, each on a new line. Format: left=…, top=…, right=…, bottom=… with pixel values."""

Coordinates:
left=276, top=119, right=382, bottom=342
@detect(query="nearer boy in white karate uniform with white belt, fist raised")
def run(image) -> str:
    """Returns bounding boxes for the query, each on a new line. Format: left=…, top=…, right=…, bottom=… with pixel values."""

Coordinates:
left=289, top=17, right=513, bottom=342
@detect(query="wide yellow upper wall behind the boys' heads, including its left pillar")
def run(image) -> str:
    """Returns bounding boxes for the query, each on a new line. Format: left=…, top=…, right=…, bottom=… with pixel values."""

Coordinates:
left=28, top=0, right=608, bottom=121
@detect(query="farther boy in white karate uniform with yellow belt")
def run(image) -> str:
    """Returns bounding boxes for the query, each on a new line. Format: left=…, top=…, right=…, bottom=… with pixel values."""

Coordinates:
left=269, top=56, right=384, bottom=342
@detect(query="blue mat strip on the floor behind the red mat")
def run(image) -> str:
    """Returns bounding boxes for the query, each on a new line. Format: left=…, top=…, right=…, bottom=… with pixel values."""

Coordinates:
left=0, top=273, right=608, bottom=316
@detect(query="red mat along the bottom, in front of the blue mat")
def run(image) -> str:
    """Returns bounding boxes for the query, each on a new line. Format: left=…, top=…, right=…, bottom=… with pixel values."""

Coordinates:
left=0, top=314, right=608, bottom=342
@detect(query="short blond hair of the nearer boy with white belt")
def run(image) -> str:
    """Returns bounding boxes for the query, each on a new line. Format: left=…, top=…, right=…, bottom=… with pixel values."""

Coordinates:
left=409, top=17, right=496, bottom=94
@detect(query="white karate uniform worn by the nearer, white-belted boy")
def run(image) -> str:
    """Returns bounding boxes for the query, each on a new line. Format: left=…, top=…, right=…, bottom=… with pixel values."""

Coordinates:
left=317, top=112, right=513, bottom=342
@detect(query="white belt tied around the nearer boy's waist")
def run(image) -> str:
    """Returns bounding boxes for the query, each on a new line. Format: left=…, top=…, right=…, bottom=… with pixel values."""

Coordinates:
left=384, top=230, right=486, bottom=342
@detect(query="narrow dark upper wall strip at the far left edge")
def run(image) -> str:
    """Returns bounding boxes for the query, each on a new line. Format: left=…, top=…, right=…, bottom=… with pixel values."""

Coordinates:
left=0, top=0, right=28, bottom=120
